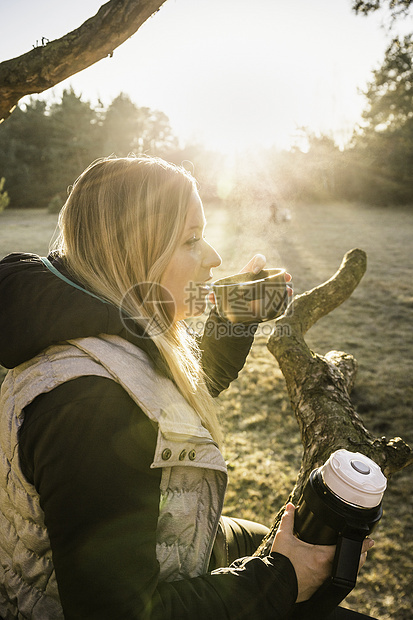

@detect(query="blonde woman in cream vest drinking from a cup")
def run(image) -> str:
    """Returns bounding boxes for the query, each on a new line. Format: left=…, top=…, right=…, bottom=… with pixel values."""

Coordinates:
left=0, top=157, right=374, bottom=620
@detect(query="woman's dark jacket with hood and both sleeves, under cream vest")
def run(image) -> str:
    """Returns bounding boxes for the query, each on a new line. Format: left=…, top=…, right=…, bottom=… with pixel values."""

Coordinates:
left=0, top=255, right=297, bottom=620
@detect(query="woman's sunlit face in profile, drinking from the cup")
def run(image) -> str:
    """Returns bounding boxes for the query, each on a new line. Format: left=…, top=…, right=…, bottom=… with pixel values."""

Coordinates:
left=161, top=191, right=221, bottom=321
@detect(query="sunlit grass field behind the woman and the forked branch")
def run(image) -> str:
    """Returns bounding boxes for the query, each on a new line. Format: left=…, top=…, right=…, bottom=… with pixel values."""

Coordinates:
left=0, top=204, right=413, bottom=620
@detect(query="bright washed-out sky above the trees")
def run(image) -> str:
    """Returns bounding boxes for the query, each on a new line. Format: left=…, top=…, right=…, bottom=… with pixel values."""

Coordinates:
left=0, top=0, right=413, bottom=152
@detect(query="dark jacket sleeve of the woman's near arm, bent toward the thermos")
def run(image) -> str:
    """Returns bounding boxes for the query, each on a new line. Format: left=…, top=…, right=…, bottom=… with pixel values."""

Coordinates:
left=19, top=377, right=297, bottom=620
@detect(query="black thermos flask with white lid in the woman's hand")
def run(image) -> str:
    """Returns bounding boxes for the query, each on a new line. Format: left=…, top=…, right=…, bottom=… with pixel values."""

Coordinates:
left=292, top=450, right=387, bottom=620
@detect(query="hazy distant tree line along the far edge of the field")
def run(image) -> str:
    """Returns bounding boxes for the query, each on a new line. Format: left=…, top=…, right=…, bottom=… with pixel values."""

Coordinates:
left=0, top=35, right=413, bottom=210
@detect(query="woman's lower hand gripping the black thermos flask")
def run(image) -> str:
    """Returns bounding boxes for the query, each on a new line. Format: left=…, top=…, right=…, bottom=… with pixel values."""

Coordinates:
left=271, top=504, right=374, bottom=603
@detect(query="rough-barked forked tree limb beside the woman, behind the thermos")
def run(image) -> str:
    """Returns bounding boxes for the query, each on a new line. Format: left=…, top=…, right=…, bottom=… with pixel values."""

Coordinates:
left=257, top=249, right=413, bottom=555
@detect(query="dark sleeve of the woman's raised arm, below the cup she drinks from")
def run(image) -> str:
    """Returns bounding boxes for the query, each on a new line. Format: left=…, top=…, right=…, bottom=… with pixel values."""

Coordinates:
left=199, top=309, right=258, bottom=397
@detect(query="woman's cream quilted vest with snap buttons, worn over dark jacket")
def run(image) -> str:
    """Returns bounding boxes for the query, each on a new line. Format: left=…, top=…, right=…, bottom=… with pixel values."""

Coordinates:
left=0, top=335, right=227, bottom=620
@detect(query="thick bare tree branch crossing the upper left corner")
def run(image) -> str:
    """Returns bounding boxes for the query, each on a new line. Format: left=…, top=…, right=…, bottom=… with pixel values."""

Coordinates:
left=0, top=0, right=165, bottom=122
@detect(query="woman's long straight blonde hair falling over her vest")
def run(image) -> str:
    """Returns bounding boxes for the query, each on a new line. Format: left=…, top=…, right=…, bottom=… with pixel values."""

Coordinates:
left=54, top=156, right=221, bottom=444
